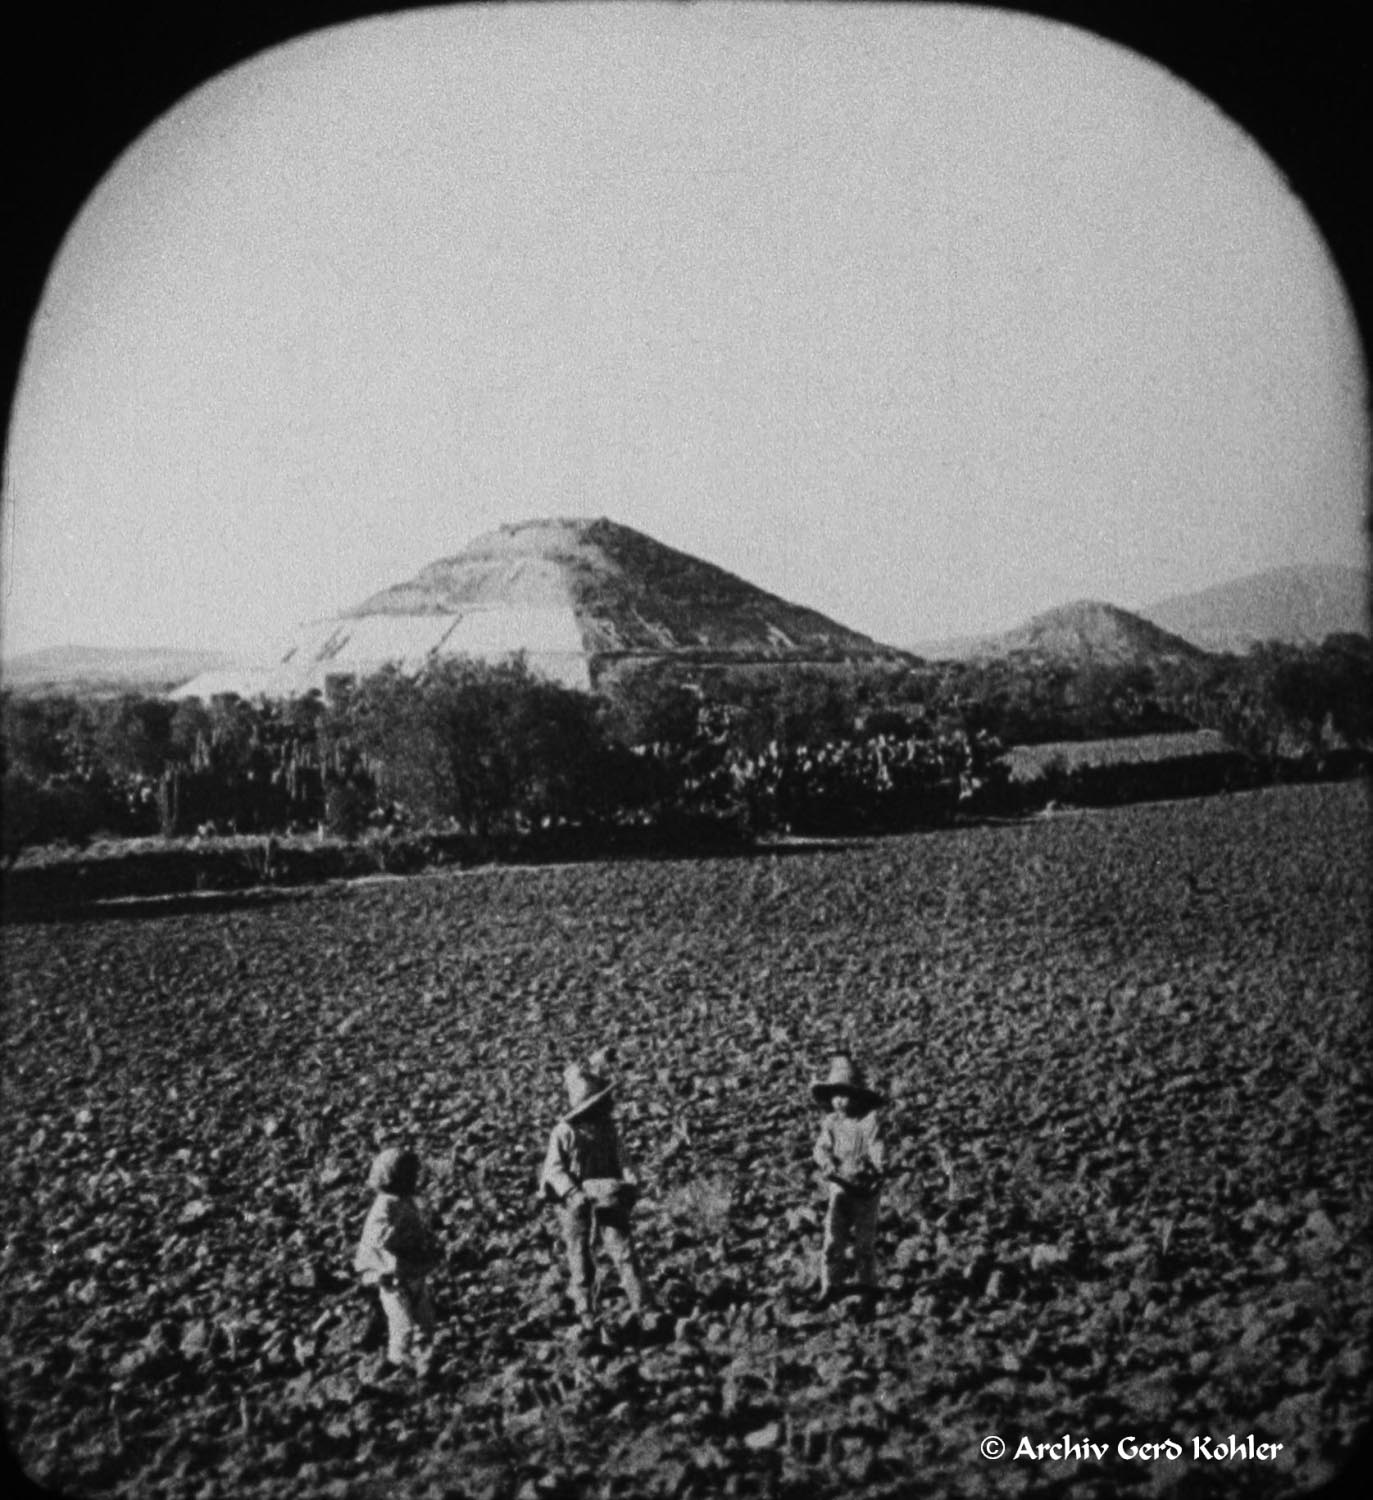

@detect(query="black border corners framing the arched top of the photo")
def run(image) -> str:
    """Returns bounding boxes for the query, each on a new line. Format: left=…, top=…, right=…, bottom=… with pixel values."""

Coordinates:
left=8, top=0, right=1373, bottom=480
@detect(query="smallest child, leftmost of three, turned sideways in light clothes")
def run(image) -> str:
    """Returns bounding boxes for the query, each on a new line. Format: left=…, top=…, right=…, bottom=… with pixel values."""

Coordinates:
left=353, top=1146, right=438, bottom=1370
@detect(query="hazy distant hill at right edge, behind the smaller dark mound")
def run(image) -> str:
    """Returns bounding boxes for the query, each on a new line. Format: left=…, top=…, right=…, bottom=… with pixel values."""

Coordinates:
left=1140, top=563, right=1370, bottom=651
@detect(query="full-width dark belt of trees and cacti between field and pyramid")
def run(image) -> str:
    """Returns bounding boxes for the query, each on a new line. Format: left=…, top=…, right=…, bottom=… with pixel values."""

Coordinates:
left=0, top=636, right=1373, bottom=860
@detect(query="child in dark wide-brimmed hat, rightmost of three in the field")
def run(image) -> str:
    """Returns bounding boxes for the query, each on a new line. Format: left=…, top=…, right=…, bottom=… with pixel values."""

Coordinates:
left=810, top=1053, right=887, bottom=1305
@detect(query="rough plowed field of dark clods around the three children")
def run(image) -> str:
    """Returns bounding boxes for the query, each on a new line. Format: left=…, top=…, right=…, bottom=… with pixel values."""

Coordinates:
left=0, top=785, right=1373, bottom=1500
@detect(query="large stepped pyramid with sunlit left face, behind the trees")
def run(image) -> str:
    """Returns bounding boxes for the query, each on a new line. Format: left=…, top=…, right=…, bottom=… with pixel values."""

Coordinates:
left=176, top=519, right=909, bottom=698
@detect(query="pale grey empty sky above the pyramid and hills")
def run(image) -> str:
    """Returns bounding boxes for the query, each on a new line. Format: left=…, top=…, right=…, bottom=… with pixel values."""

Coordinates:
left=3, top=5, right=1368, bottom=654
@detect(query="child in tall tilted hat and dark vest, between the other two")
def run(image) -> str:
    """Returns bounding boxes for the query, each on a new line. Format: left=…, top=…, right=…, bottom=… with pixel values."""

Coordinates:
left=539, top=1055, right=645, bottom=1331
